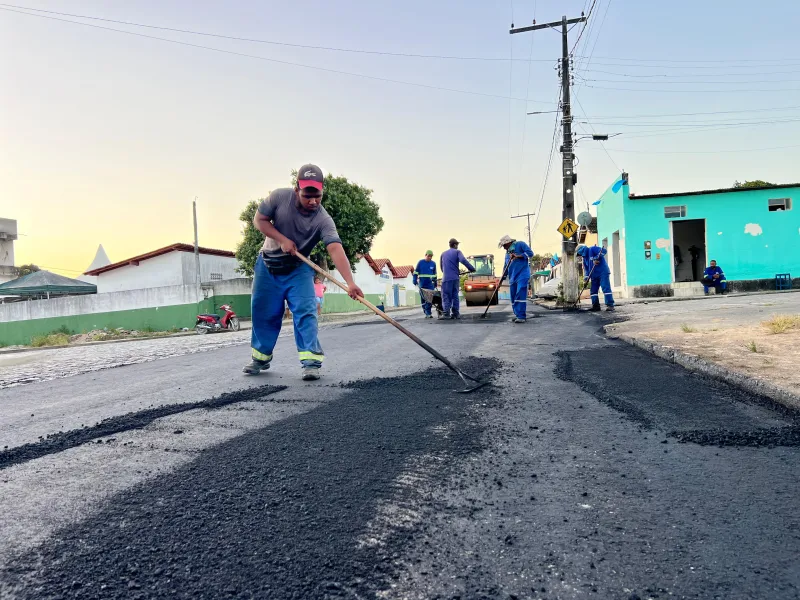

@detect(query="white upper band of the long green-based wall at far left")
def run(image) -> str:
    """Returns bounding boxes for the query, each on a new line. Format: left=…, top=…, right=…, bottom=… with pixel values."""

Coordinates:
left=0, top=285, right=203, bottom=323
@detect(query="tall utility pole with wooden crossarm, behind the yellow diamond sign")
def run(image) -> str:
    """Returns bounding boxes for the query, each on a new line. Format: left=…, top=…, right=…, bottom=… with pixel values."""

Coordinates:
left=509, top=13, right=586, bottom=306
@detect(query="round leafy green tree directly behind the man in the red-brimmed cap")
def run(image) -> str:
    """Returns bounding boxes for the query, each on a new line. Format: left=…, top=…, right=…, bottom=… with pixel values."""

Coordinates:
left=236, top=171, right=384, bottom=277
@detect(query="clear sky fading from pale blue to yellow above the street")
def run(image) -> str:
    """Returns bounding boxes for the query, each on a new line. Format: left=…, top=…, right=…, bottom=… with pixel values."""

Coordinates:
left=0, top=0, right=800, bottom=276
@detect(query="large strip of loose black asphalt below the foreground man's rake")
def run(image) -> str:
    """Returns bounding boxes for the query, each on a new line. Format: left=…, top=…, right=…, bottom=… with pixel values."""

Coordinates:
left=3, top=359, right=495, bottom=599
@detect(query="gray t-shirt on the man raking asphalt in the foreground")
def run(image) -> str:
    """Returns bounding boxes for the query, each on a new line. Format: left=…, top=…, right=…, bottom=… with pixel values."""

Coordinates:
left=258, top=188, right=342, bottom=256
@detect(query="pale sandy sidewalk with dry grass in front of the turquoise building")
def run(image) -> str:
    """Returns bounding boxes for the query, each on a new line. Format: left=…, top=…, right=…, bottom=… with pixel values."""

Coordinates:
left=602, top=293, right=800, bottom=408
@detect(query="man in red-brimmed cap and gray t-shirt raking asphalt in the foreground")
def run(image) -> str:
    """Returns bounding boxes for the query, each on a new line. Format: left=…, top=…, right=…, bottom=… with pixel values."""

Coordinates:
left=243, top=165, right=364, bottom=381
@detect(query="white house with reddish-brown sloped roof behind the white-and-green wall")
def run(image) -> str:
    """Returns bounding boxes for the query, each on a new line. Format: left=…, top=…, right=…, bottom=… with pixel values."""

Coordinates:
left=84, top=244, right=241, bottom=294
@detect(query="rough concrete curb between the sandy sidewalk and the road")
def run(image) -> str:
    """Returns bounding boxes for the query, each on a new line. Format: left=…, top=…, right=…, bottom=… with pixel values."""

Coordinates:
left=604, top=326, right=800, bottom=410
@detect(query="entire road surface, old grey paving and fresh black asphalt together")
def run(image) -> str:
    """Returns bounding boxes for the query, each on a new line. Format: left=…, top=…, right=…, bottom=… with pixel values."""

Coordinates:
left=0, top=307, right=800, bottom=599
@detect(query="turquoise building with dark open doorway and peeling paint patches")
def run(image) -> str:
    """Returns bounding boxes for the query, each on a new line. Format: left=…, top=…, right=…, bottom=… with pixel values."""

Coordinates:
left=595, top=173, right=800, bottom=298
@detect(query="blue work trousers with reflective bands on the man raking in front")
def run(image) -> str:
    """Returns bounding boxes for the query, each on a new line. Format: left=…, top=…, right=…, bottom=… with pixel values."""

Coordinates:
left=250, top=256, right=325, bottom=368
